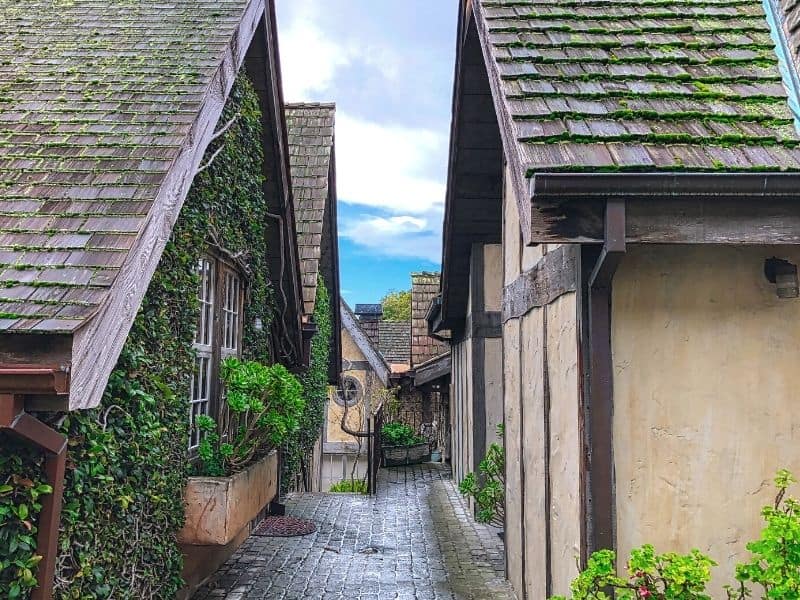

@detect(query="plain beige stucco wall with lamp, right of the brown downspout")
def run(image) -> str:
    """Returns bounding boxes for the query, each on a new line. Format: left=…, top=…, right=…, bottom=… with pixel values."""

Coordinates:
left=613, top=247, right=800, bottom=598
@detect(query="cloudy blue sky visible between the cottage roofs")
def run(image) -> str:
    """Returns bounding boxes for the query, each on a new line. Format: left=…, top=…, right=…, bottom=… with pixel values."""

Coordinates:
left=277, top=0, right=458, bottom=304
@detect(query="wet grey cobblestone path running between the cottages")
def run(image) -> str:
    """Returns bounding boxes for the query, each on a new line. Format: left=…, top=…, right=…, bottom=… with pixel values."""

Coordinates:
left=194, top=464, right=514, bottom=600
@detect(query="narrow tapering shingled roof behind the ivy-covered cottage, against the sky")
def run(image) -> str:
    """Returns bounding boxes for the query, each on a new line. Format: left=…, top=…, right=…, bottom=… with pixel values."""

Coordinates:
left=286, top=104, right=336, bottom=315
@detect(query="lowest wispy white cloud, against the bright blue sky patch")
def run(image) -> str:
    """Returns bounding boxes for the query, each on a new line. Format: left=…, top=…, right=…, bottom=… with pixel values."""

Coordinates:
left=339, top=210, right=442, bottom=264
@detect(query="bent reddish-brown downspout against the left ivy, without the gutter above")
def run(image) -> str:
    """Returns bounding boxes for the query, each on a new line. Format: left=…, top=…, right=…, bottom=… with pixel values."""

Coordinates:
left=0, top=384, right=67, bottom=600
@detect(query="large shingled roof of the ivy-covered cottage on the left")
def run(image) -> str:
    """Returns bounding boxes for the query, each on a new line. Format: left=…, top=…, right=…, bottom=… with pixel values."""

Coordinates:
left=0, top=0, right=264, bottom=332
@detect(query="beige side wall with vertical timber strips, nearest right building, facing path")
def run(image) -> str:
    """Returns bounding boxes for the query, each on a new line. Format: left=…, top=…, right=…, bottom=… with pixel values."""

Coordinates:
left=502, top=166, right=583, bottom=600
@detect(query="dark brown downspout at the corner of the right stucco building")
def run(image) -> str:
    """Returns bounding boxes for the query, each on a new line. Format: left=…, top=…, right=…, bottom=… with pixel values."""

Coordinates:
left=587, top=200, right=626, bottom=554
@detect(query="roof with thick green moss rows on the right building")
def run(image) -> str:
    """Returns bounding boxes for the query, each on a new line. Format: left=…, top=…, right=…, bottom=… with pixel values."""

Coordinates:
left=473, top=0, right=800, bottom=177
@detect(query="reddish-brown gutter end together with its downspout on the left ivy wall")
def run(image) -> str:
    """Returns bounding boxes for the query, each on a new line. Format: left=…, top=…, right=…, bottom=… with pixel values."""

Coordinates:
left=0, top=367, right=69, bottom=600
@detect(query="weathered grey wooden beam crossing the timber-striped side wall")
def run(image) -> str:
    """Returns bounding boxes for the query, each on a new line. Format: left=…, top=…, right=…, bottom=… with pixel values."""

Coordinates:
left=503, top=245, right=580, bottom=322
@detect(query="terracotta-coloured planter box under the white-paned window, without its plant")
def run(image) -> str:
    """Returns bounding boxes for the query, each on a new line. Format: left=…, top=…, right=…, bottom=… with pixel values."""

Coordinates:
left=178, top=452, right=278, bottom=546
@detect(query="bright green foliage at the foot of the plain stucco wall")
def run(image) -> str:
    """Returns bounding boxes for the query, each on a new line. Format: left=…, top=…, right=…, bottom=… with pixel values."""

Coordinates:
left=551, top=470, right=800, bottom=600
